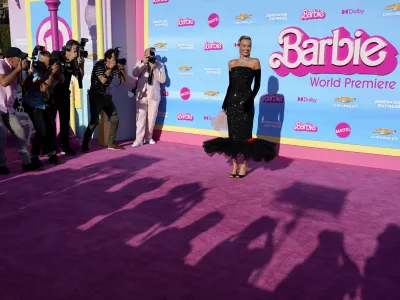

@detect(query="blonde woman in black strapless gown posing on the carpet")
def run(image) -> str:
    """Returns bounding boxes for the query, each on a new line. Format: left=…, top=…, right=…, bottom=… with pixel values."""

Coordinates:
left=203, top=36, right=276, bottom=178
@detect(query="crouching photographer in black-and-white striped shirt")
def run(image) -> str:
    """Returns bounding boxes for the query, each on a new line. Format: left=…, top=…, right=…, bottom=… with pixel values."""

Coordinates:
left=82, top=49, right=126, bottom=153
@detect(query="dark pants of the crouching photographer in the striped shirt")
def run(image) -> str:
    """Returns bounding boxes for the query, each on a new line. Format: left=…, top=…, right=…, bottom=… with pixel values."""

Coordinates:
left=82, top=92, right=119, bottom=149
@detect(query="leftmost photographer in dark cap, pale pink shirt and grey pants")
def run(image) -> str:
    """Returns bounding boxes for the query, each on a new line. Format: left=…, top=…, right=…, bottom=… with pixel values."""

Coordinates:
left=0, top=47, right=42, bottom=175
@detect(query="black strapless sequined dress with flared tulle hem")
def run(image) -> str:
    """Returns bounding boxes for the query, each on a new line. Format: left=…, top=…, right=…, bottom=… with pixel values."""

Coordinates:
left=203, top=66, right=276, bottom=162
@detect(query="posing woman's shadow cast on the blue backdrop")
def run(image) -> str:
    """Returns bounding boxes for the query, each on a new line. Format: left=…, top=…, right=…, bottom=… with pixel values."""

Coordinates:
left=257, top=76, right=285, bottom=155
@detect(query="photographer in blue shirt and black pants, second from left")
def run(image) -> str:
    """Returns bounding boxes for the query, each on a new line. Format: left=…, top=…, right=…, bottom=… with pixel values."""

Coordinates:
left=24, top=51, right=64, bottom=165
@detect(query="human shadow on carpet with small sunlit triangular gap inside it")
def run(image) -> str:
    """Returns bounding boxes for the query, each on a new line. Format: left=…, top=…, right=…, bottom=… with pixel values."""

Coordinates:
left=191, top=216, right=278, bottom=299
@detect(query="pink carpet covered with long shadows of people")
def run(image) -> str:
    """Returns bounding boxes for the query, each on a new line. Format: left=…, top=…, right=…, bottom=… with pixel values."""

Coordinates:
left=0, top=143, right=400, bottom=300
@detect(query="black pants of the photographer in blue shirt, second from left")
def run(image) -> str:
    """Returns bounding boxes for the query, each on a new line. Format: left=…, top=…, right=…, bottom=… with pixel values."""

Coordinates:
left=24, top=105, right=57, bottom=156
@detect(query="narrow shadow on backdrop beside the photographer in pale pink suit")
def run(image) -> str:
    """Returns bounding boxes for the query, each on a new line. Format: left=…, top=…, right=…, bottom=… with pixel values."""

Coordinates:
left=154, top=55, right=171, bottom=141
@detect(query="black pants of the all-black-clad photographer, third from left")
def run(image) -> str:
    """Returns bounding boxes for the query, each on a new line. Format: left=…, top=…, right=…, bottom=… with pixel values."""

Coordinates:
left=54, top=91, right=71, bottom=150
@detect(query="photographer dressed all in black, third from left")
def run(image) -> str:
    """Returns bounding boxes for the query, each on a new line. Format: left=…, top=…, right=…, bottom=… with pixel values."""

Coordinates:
left=53, top=40, right=85, bottom=155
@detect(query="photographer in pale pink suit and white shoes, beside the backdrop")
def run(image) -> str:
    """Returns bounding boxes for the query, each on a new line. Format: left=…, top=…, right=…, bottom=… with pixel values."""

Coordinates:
left=132, top=48, right=167, bottom=147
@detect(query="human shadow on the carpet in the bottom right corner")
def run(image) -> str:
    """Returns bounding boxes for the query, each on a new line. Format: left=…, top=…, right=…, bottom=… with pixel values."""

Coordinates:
left=362, top=224, right=400, bottom=300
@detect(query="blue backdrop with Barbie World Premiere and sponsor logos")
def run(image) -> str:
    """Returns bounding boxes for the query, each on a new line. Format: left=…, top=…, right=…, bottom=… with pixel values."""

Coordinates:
left=148, top=0, right=400, bottom=149
